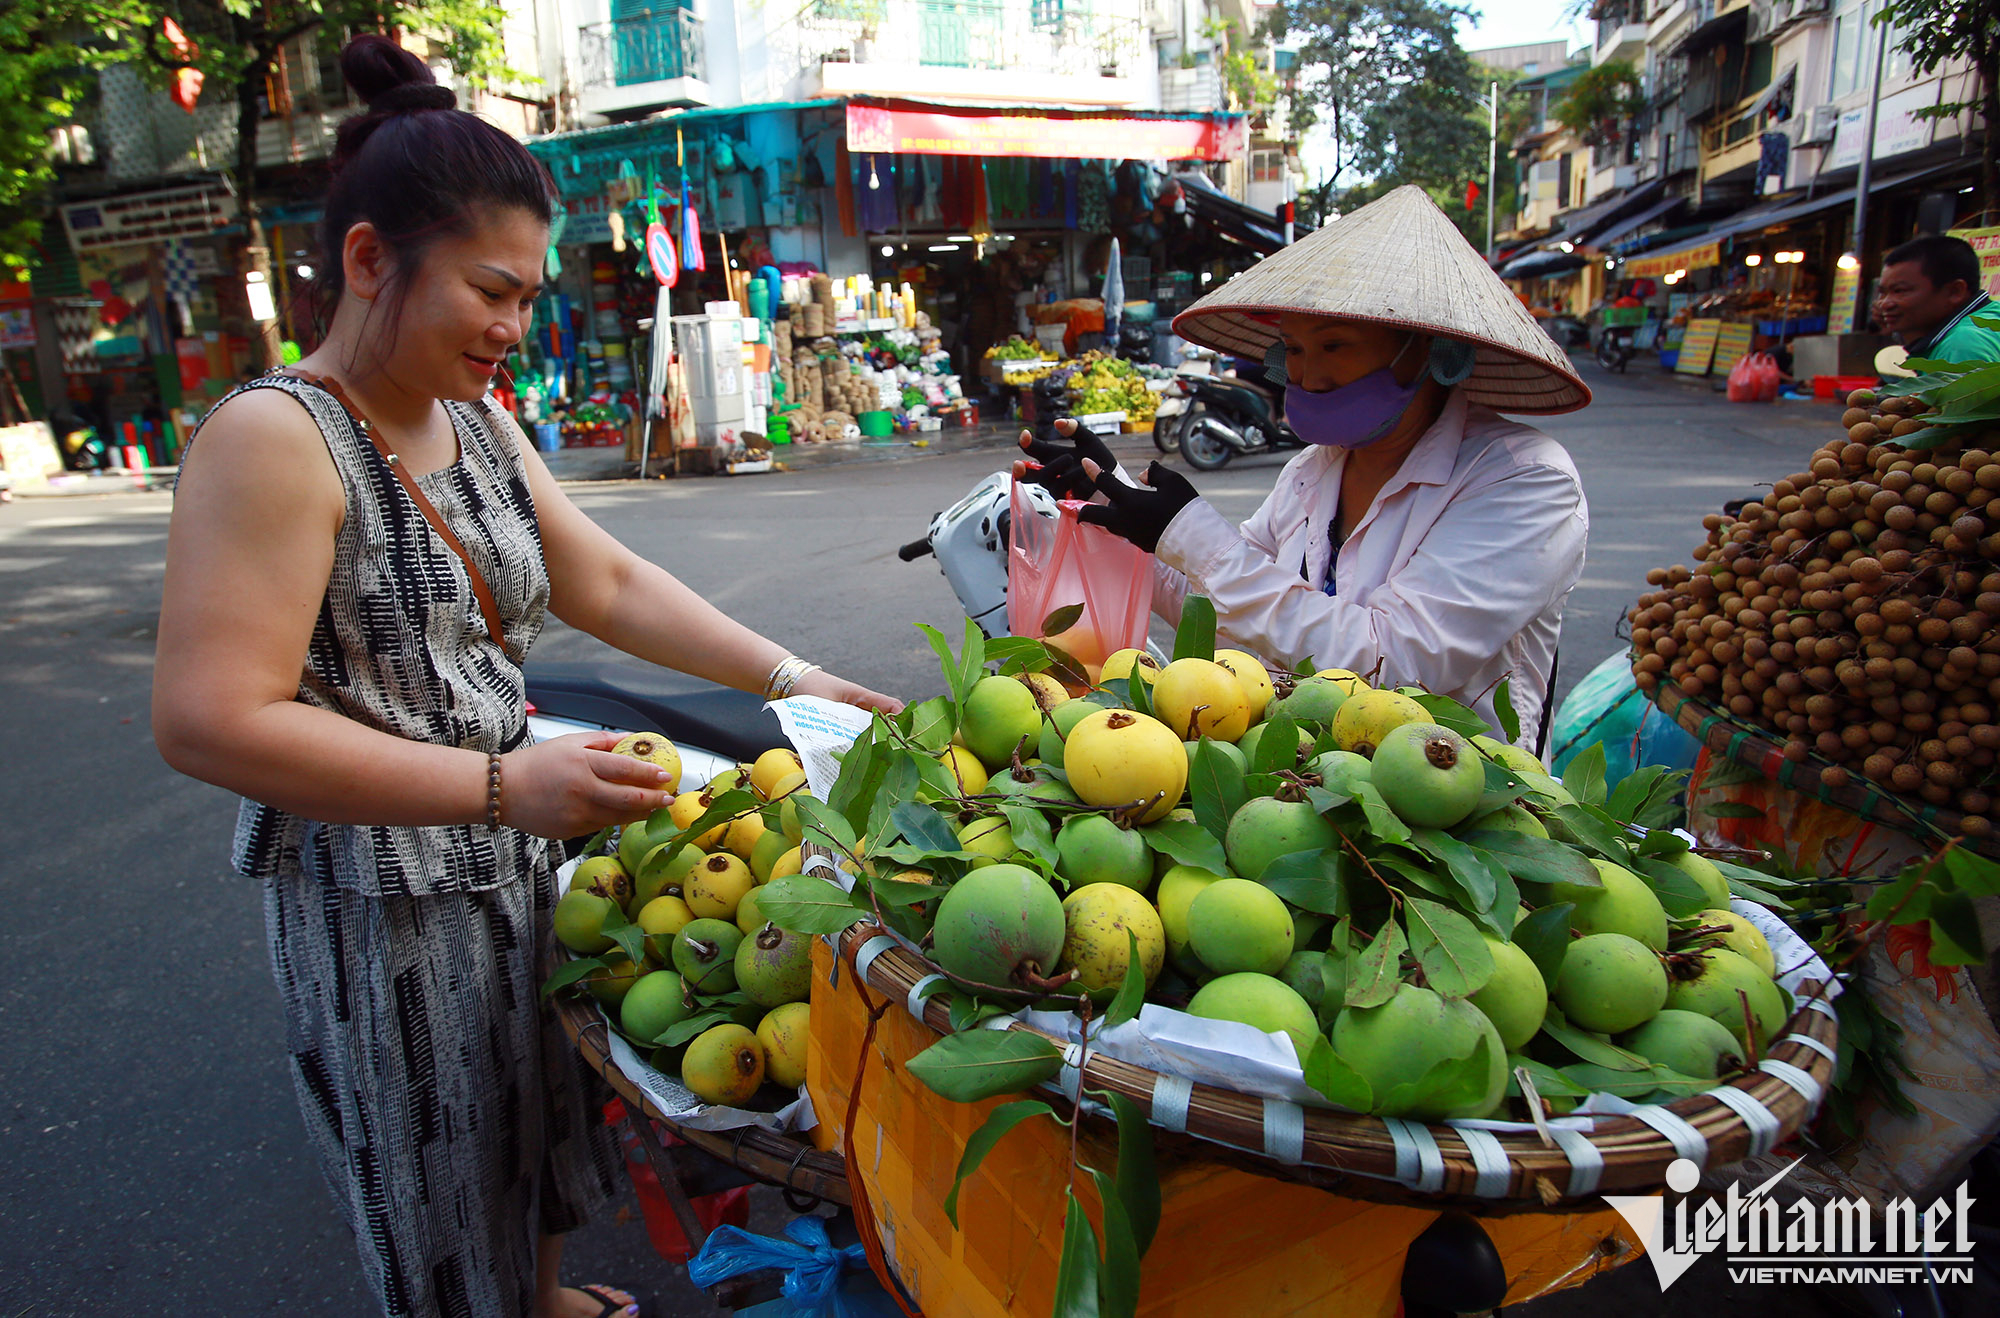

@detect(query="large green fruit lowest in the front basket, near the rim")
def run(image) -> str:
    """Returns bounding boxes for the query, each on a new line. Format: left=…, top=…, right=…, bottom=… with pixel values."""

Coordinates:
left=1332, top=984, right=1506, bottom=1122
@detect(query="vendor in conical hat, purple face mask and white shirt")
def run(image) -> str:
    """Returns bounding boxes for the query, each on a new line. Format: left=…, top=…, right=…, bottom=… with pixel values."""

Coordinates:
left=1022, top=188, right=1590, bottom=746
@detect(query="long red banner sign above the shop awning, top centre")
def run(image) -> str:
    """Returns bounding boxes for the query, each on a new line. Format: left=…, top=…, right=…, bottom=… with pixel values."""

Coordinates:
left=848, top=104, right=1250, bottom=160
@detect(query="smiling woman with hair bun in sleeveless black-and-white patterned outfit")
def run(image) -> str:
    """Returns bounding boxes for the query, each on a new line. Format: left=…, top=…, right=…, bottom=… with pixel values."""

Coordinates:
left=154, top=36, right=900, bottom=1318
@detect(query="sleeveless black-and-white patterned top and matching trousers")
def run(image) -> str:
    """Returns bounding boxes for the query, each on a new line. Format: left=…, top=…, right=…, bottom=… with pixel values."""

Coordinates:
left=196, top=374, right=620, bottom=1318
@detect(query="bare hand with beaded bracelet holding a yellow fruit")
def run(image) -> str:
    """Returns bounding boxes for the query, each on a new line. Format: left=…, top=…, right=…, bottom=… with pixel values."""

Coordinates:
left=500, top=732, right=674, bottom=838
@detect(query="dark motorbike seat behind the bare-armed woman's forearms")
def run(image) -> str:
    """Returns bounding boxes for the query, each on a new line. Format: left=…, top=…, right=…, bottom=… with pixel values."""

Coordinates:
left=524, top=662, right=788, bottom=762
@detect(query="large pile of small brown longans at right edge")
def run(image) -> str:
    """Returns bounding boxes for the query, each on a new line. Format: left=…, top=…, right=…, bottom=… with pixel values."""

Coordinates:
left=1628, top=390, right=2000, bottom=836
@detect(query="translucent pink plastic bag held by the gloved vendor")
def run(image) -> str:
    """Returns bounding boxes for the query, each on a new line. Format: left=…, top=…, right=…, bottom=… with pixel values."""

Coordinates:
left=1006, top=482, right=1152, bottom=668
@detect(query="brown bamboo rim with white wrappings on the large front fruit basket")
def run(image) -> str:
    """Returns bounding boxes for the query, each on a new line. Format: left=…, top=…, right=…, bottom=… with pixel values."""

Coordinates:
left=820, top=924, right=1836, bottom=1216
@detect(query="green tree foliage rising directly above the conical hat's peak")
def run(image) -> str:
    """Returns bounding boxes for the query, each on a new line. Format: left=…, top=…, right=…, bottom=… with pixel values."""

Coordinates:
left=1272, top=0, right=1486, bottom=227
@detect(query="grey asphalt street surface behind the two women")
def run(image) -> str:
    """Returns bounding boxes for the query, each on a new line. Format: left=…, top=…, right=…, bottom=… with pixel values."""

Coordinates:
left=0, top=366, right=1864, bottom=1318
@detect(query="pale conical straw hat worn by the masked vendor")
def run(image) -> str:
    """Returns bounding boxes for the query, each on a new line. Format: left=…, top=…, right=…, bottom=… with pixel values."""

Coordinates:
left=1174, top=186, right=1590, bottom=412
